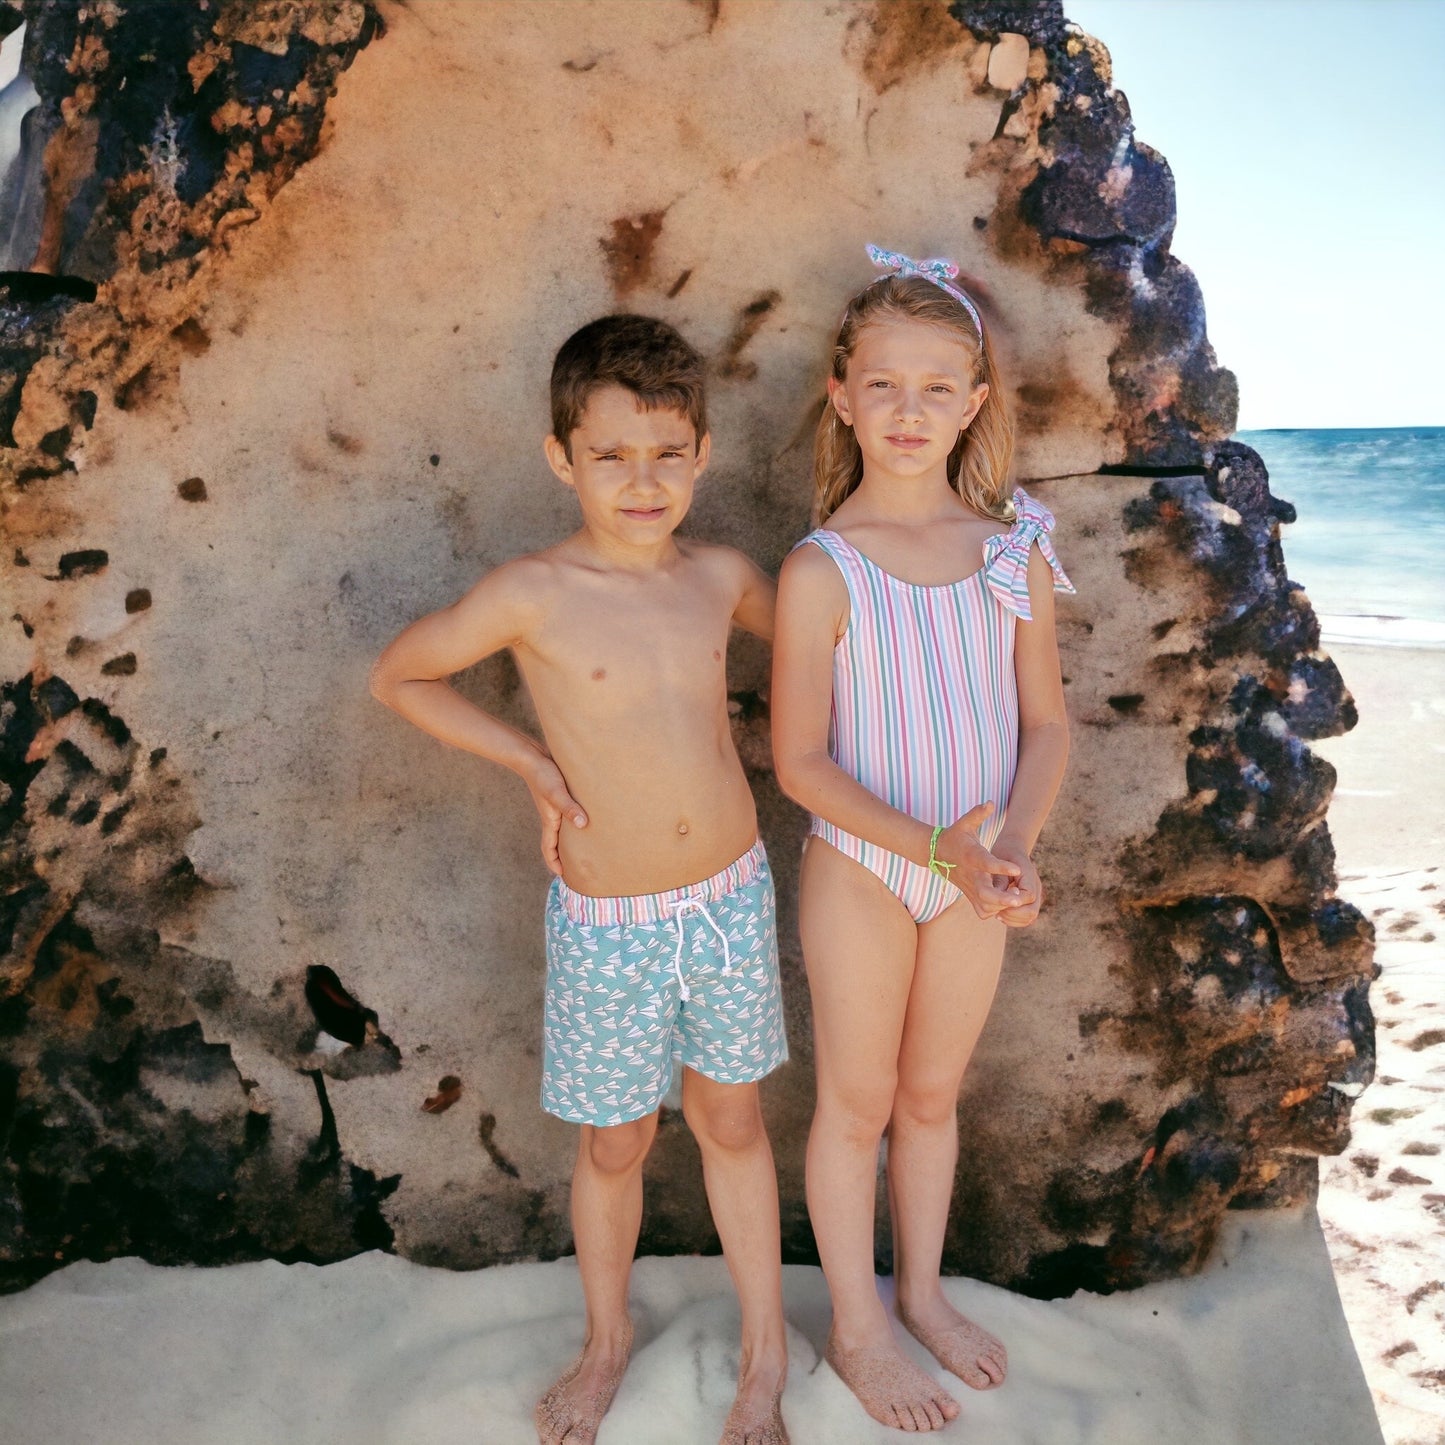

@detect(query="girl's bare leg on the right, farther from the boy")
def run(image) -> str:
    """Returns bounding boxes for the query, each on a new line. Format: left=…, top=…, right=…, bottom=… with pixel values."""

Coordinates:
left=889, top=900, right=1007, bottom=1390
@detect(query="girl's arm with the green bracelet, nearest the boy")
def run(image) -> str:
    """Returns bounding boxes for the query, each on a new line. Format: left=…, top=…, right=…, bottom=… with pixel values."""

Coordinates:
left=772, top=546, right=1022, bottom=918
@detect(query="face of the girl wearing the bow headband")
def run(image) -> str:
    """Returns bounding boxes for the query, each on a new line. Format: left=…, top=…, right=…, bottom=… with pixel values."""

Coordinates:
left=828, top=321, right=988, bottom=478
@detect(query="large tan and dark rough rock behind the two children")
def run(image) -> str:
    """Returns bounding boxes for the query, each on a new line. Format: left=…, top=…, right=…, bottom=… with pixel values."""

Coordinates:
left=0, top=0, right=1373, bottom=1295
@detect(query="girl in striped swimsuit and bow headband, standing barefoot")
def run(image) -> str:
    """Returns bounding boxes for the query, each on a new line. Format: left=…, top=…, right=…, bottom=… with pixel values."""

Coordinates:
left=773, top=246, right=1074, bottom=1431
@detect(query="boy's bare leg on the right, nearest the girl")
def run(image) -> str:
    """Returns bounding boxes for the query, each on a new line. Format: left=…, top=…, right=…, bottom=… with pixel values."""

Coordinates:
left=682, top=1069, right=788, bottom=1445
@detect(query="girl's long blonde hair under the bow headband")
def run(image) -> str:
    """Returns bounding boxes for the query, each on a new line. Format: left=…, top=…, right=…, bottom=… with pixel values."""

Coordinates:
left=814, top=276, right=1013, bottom=526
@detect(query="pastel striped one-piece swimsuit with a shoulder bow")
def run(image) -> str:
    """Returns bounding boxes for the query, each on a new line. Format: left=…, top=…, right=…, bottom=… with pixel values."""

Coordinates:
left=798, top=488, right=1074, bottom=923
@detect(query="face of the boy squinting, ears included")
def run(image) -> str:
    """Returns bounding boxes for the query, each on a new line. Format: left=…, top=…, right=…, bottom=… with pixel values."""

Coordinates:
left=546, top=386, right=709, bottom=546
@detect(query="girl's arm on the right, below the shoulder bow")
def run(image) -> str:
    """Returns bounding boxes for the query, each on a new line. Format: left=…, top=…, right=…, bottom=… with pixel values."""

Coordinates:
left=994, top=548, right=1069, bottom=928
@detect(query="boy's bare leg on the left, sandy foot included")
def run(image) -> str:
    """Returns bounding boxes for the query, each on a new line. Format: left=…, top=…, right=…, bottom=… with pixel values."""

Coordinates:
left=536, top=1113, right=657, bottom=1445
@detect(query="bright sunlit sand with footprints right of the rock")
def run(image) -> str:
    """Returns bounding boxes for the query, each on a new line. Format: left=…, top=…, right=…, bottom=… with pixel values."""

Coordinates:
left=1318, top=642, right=1445, bottom=1445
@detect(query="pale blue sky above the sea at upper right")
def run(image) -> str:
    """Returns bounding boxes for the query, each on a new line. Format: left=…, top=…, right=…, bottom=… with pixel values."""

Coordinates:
left=1064, top=0, right=1445, bottom=428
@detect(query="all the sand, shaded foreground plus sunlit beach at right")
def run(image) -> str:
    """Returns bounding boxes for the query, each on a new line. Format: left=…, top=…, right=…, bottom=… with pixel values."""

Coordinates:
left=8, top=646, right=1445, bottom=1445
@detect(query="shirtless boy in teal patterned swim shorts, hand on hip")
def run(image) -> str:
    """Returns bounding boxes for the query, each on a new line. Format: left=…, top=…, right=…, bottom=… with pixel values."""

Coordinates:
left=371, top=316, right=788, bottom=1445
